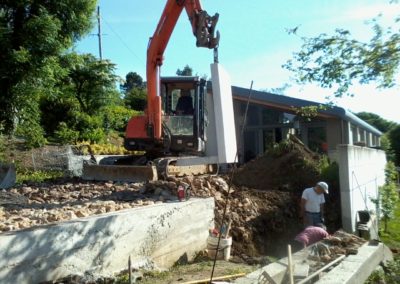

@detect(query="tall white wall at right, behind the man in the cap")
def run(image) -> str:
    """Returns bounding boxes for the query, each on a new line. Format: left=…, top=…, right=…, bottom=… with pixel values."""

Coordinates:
left=338, top=145, right=386, bottom=233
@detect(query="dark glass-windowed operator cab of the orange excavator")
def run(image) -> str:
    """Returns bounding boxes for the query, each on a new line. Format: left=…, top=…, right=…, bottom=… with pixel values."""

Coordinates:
left=160, top=76, right=206, bottom=155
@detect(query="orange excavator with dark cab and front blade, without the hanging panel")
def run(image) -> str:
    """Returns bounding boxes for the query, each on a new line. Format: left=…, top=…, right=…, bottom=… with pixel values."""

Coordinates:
left=82, top=0, right=225, bottom=181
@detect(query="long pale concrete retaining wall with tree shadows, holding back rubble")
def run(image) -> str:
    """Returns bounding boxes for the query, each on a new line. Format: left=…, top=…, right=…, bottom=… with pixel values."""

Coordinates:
left=0, top=198, right=214, bottom=283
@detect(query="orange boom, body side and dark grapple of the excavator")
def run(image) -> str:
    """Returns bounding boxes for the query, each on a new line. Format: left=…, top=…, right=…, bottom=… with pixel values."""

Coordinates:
left=126, top=0, right=219, bottom=143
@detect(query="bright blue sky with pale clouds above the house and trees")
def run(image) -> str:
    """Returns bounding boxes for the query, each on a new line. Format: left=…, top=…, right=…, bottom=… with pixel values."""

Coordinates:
left=76, top=0, right=400, bottom=123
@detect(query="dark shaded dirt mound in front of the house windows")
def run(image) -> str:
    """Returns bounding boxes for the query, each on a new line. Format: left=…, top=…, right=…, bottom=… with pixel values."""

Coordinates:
left=233, top=137, right=320, bottom=191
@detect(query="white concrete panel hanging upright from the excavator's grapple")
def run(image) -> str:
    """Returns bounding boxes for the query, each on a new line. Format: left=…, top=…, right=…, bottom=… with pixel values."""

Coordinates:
left=211, top=63, right=237, bottom=163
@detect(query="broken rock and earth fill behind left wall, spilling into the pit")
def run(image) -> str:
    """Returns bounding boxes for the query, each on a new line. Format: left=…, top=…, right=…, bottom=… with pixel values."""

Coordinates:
left=0, top=176, right=297, bottom=260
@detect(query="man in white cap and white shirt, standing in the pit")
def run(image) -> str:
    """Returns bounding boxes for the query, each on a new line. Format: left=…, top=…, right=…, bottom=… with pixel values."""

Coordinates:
left=301, top=181, right=329, bottom=227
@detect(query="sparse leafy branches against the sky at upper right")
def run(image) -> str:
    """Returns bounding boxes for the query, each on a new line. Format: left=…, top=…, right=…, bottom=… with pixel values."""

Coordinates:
left=284, top=5, right=400, bottom=96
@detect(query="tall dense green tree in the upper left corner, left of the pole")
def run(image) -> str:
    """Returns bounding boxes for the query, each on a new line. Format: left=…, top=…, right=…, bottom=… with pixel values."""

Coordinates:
left=0, top=0, right=96, bottom=134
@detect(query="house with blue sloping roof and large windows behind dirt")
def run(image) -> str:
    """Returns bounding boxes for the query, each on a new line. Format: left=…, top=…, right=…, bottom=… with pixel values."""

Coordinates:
left=232, top=86, right=382, bottom=163
